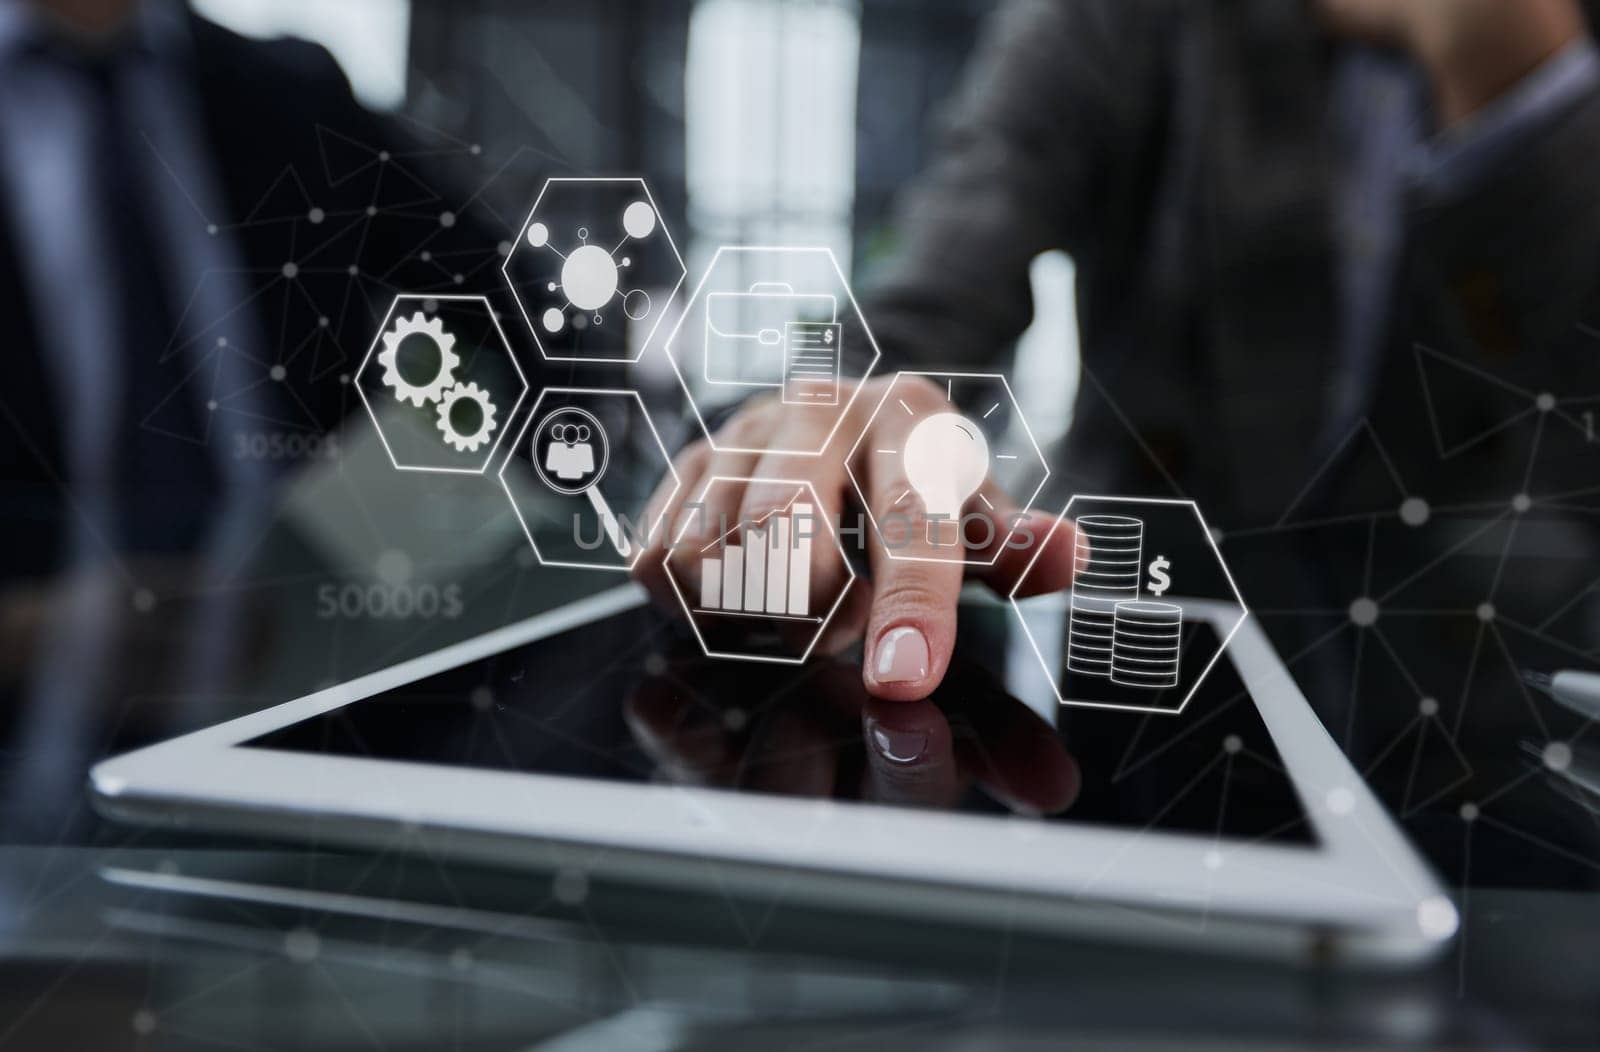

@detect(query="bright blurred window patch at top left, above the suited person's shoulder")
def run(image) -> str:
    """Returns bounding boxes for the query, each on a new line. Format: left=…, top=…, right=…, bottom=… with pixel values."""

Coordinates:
left=194, top=0, right=411, bottom=110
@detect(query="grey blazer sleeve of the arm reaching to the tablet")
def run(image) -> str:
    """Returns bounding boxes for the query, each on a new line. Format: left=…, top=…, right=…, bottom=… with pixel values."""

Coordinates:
left=864, top=0, right=1163, bottom=368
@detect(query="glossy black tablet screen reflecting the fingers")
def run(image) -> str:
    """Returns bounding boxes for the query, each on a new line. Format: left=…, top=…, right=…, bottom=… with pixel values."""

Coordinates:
left=245, top=604, right=1315, bottom=846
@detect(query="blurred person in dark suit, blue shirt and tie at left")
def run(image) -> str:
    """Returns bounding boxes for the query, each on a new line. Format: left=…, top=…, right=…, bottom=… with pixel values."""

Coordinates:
left=0, top=0, right=496, bottom=836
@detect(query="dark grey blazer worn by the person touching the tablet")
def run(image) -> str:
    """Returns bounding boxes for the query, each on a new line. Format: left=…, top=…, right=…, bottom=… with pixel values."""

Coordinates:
left=867, top=0, right=1600, bottom=528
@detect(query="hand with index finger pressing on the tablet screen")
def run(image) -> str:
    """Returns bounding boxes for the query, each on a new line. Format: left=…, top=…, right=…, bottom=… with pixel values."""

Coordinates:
left=635, top=377, right=1075, bottom=702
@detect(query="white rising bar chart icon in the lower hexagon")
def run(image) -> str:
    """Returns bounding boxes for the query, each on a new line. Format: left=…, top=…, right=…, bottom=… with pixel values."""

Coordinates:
left=696, top=494, right=822, bottom=622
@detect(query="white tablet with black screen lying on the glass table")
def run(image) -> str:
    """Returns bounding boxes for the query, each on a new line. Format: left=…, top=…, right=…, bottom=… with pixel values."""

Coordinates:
left=91, top=587, right=1456, bottom=962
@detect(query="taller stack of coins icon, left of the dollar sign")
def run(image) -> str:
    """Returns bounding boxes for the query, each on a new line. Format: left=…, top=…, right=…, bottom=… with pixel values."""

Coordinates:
left=1067, top=515, right=1144, bottom=676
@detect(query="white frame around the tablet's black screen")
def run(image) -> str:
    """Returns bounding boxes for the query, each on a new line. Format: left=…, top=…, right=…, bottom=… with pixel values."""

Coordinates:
left=90, top=585, right=1456, bottom=961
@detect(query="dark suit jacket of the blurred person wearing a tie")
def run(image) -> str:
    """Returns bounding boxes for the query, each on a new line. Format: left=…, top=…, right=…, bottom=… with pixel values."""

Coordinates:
left=0, top=10, right=498, bottom=580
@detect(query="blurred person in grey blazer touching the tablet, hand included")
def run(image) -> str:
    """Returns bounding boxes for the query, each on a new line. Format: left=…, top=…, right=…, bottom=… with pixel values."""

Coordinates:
left=643, top=0, right=1600, bottom=713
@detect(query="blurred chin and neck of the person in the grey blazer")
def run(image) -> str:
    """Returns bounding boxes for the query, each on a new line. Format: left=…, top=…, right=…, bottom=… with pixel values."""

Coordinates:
left=1317, top=0, right=1587, bottom=128
